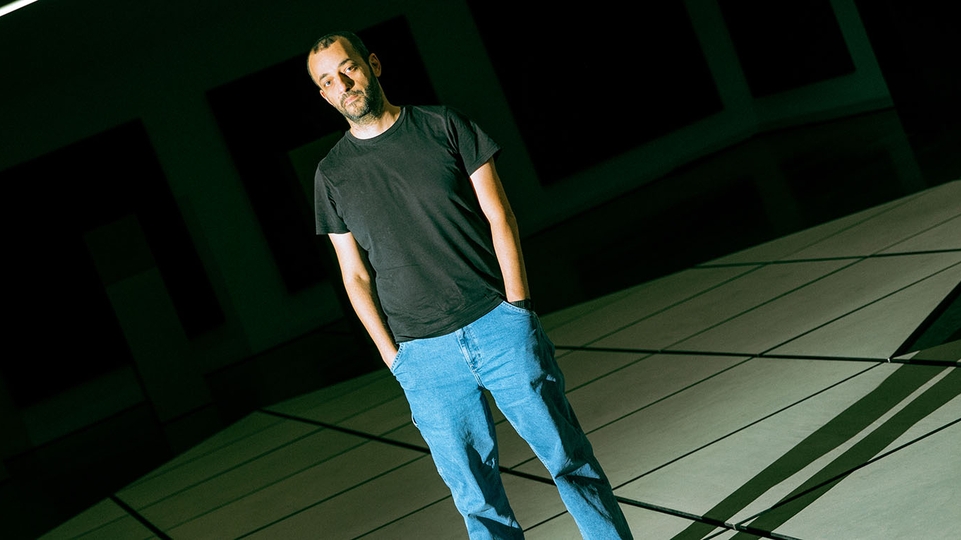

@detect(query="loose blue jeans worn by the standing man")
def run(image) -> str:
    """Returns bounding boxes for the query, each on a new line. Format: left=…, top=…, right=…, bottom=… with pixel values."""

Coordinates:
left=391, top=302, right=632, bottom=539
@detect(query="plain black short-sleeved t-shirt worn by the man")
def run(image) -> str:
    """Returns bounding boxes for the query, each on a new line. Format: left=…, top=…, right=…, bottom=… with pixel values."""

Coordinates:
left=314, top=106, right=504, bottom=342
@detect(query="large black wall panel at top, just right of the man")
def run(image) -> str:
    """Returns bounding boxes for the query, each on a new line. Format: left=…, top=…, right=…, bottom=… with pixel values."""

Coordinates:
left=468, top=0, right=721, bottom=184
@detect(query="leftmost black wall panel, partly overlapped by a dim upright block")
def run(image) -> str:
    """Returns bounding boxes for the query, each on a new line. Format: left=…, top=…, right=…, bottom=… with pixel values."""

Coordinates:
left=0, top=121, right=223, bottom=405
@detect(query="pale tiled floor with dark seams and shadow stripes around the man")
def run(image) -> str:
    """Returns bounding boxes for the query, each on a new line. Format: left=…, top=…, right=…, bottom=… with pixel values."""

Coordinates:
left=43, top=181, right=961, bottom=540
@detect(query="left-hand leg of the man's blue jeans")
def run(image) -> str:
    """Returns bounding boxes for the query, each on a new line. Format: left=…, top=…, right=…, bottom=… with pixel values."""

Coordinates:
left=391, top=334, right=523, bottom=540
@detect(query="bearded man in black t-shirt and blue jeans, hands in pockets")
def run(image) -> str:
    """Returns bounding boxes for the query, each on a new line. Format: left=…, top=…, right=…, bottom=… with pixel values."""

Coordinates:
left=307, top=32, right=631, bottom=539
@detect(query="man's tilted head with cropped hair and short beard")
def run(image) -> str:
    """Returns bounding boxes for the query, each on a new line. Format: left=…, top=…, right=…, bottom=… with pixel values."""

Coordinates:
left=307, top=39, right=384, bottom=124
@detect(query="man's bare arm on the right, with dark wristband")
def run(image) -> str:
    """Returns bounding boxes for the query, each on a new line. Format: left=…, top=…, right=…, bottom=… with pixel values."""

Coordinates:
left=470, top=159, right=530, bottom=302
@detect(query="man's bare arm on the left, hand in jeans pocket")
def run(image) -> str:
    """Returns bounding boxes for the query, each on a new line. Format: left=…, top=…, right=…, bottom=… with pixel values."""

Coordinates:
left=328, top=233, right=397, bottom=367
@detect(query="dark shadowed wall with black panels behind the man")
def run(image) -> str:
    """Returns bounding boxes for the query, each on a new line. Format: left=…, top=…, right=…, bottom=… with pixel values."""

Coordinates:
left=0, top=0, right=961, bottom=531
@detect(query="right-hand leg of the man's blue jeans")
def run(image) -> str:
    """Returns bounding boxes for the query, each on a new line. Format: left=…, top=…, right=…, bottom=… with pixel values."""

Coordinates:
left=466, top=303, right=632, bottom=539
